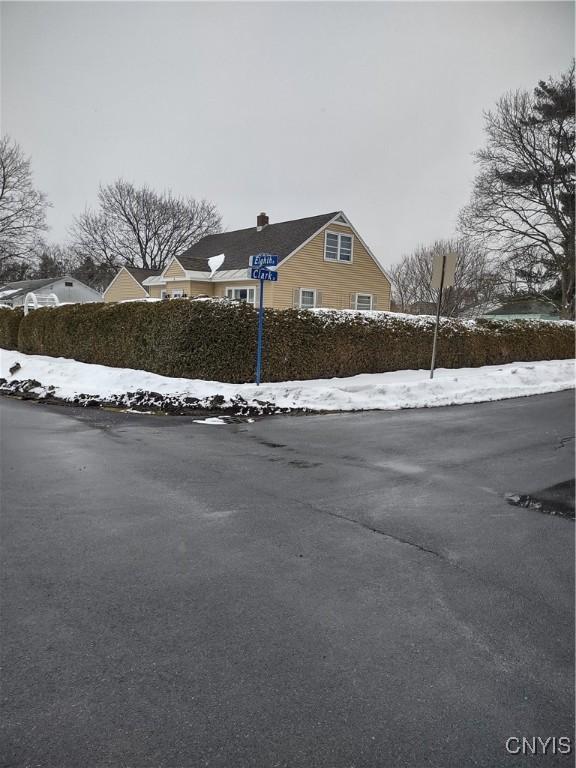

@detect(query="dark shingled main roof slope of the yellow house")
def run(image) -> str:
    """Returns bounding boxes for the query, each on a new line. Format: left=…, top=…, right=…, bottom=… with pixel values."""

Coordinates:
left=177, top=211, right=340, bottom=272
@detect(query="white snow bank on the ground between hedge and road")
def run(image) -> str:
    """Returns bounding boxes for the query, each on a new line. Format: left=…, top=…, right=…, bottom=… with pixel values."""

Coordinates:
left=0, top=350, right=574, bottom=411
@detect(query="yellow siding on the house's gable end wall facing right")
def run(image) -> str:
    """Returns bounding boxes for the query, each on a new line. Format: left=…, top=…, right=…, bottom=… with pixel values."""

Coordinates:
left=269, top=224, right=390, bottom=310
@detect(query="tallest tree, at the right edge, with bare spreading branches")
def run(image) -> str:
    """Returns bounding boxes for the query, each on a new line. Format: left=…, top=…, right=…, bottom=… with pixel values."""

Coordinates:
left=460, top=64, right=574, bottom=318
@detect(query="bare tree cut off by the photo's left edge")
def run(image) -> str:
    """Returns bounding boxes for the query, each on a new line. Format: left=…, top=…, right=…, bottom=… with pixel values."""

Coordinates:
left=0, top=136, right=48, bottom=273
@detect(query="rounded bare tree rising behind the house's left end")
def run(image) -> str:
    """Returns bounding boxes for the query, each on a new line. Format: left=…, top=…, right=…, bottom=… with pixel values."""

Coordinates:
left=71, top=179, right=221, bottom=269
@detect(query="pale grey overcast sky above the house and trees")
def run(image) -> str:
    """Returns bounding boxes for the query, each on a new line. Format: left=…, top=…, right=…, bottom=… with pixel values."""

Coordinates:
left=1, top=2, right=574, bottom=265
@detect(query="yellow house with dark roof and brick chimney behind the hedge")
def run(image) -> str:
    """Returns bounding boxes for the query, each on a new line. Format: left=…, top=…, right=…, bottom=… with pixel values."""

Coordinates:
left=104, top=211, right=390, bottom=310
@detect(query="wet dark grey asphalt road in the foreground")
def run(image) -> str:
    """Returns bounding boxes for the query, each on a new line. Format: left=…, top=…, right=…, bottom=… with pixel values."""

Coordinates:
left=0, top=392, right=574, bottom=768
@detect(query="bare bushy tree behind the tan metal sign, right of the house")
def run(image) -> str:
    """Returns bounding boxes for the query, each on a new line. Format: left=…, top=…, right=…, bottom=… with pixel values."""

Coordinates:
left=389, top=240, right=499, bottom=317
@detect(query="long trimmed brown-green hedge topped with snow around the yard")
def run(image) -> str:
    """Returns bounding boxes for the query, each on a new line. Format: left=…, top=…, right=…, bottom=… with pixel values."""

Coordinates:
left=0, top=300, right=574, bottom=382
